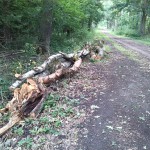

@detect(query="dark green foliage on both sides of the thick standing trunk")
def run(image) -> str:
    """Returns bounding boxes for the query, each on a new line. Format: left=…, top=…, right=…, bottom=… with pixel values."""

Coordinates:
left=0, top=0, right=103, bottom=54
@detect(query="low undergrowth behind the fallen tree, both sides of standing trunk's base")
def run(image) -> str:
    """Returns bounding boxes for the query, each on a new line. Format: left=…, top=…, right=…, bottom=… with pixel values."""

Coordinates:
left=0, top=29, right=95, bottom=105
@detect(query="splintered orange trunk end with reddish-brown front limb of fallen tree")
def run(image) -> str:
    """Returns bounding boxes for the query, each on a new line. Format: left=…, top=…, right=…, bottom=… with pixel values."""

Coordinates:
left=0, top=58, right=82, bottom=135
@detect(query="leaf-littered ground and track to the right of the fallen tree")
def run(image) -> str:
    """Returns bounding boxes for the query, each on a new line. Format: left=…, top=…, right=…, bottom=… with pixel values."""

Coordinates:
left=0, top=32, right=150, bottom=150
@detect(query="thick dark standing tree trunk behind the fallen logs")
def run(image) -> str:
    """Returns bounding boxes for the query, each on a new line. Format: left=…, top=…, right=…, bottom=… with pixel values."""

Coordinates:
left=37, top=0, right=54, bottom=54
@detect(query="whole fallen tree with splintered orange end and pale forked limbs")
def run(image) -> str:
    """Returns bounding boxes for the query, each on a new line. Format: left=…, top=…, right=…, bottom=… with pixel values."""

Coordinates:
left=0, top=40, right=105, bottom=135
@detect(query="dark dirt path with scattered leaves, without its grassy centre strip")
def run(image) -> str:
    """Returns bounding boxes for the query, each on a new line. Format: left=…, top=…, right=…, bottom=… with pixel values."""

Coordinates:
left=77, top=33, right=150, bottom=150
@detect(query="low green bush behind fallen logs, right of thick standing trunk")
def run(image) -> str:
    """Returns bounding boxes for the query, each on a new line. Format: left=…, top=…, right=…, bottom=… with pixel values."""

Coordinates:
left=51, top=28, right=94, bottom=53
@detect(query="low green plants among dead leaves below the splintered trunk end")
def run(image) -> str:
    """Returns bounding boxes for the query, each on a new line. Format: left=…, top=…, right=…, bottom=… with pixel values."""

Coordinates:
left=12, top=93, right=79, bottom=148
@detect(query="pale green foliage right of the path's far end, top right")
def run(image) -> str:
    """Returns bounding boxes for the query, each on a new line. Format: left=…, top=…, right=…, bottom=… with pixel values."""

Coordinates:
left=104, top=0, right=150, bottom=37
